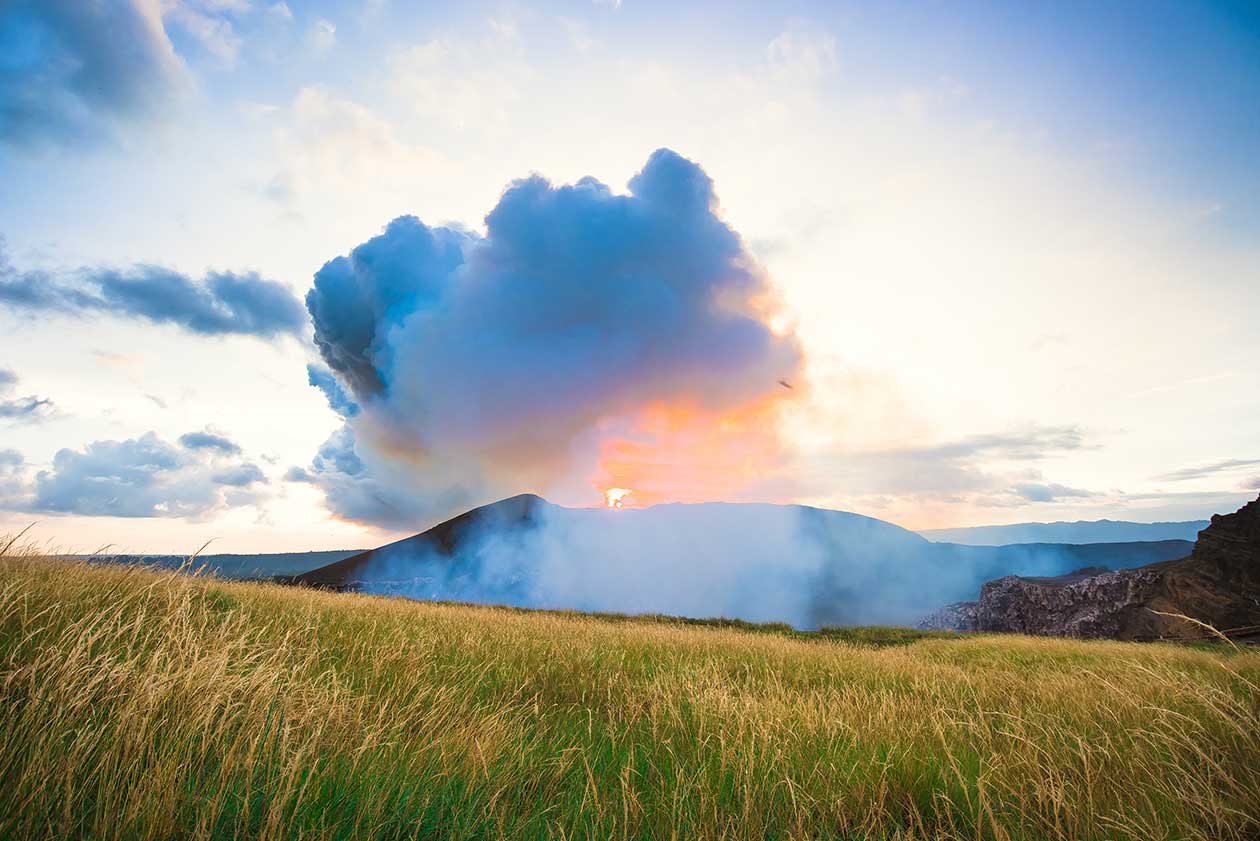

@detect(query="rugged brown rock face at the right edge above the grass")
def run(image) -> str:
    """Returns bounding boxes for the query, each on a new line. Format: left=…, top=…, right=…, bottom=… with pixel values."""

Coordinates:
left=920, top=499, right=1260, bottom=639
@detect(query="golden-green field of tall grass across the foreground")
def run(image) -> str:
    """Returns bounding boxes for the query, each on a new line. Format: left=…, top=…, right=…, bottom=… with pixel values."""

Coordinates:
left=0, top=555, right=1260, bottom=841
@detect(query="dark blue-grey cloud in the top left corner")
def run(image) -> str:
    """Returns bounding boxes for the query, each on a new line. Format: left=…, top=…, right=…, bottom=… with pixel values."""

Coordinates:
left=0, top=0, right=185, bottom=145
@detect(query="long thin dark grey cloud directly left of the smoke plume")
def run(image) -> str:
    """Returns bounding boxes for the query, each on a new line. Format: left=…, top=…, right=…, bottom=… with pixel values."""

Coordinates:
left=0, top=247, right=306, bottom=339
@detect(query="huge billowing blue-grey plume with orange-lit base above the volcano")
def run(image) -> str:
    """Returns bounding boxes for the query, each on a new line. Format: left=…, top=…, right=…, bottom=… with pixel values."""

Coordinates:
left=299, top=149, right=803, bottom=523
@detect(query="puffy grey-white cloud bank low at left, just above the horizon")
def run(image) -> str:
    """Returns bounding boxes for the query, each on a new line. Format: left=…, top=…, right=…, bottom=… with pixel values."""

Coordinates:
left=0, top=432, right=266, bottom=519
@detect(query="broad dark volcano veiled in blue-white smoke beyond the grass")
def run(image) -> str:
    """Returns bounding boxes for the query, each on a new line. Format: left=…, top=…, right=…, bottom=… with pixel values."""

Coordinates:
left=277, top=494, right=1189, bottom=628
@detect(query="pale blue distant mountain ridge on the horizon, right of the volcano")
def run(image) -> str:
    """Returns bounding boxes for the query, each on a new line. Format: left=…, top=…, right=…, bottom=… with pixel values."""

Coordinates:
left=919, top=519, right=1208, bottom=546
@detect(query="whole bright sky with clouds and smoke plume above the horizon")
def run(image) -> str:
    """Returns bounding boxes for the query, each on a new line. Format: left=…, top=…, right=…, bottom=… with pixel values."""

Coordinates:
left=0, top=0, right=1260, bottom=552
